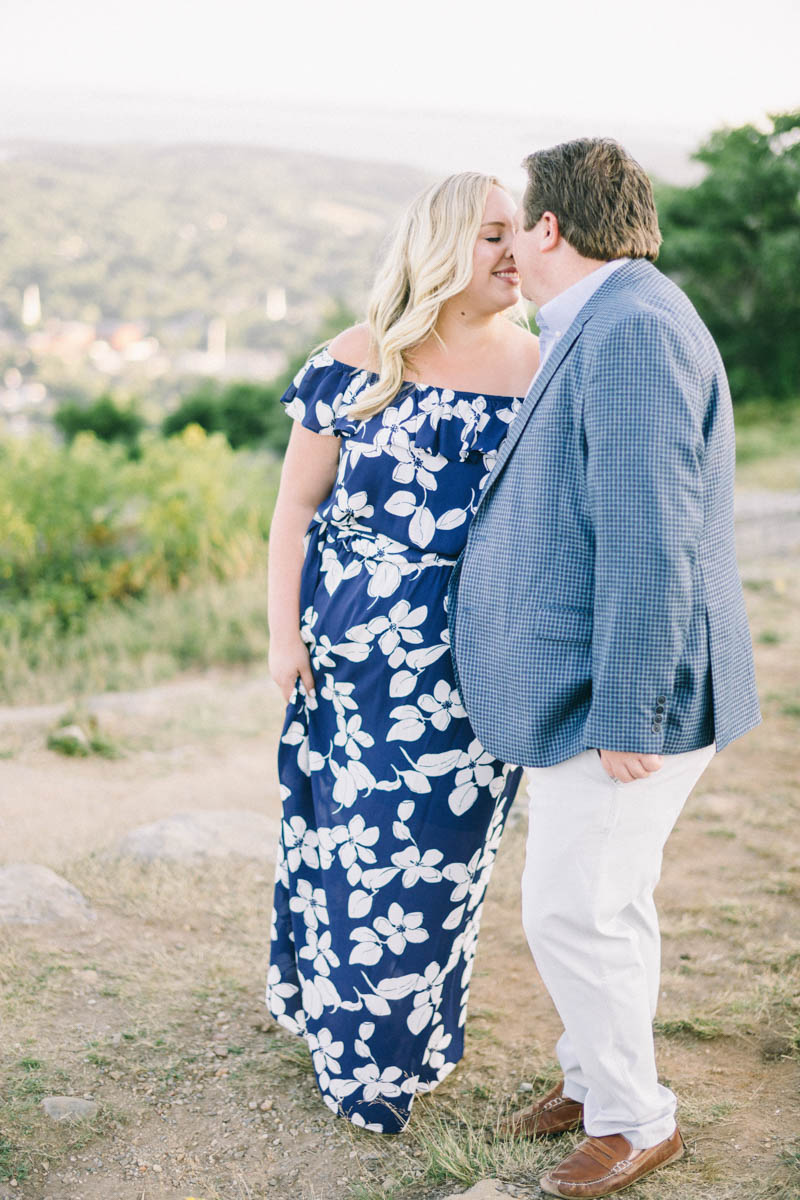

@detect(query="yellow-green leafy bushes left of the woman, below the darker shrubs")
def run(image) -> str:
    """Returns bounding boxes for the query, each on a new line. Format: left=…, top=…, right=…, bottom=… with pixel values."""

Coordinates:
left=0, top=426, right=277, bottom=655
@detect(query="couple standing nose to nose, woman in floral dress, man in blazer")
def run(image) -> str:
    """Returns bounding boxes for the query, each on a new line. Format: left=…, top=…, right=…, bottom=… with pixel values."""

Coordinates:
left=266, top=139, right=759, bottom=1198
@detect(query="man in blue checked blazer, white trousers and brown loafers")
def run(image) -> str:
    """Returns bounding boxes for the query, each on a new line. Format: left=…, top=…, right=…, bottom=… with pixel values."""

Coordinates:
left=449, top=139, right=760, bottom=1198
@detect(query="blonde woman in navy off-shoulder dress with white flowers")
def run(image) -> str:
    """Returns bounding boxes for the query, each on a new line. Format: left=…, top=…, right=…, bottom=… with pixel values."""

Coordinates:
left=267, top=174, right=539, bottom=1133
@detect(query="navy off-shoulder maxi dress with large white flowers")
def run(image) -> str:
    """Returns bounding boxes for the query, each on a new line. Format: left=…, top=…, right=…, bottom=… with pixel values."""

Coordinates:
left=266, top=350, right=519, bottom=1133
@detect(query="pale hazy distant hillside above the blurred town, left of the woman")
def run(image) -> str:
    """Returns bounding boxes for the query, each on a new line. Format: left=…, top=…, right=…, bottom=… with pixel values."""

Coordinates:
left=0, top=144, right=426, bottom=350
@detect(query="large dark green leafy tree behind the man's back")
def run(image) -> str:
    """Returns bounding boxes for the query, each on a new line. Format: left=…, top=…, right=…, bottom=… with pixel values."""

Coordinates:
left=658, top=112, right=800, bottom=400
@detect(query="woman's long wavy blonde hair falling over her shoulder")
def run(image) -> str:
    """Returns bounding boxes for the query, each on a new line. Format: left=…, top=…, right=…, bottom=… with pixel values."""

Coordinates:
left=349, top=170, right=520, bottom=420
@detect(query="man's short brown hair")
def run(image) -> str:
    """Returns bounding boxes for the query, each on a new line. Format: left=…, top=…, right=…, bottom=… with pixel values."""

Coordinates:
left=522, top=138, right=661, bottom=262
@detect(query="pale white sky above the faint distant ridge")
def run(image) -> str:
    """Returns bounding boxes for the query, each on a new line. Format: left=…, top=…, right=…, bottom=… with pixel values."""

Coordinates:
left=6, top=0, right=800, bottom=131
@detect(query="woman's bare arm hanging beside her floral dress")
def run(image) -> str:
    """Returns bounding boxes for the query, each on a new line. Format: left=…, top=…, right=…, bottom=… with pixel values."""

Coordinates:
left=269, top=425, right=341, bottom=703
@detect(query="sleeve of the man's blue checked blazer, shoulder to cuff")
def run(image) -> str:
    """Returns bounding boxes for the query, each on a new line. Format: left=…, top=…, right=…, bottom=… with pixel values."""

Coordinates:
left=584, top=312, right=705, bottom=754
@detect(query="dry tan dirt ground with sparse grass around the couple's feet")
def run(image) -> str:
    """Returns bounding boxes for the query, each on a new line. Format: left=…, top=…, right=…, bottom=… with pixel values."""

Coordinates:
left=0, top=498, right=800, bottom=1200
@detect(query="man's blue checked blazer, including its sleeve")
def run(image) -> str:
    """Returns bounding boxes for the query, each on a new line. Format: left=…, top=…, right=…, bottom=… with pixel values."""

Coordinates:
left=447, top=259, right=760, bottom=767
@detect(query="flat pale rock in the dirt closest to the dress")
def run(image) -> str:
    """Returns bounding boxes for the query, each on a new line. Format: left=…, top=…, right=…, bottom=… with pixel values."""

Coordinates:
left=119, top=809, right=279, bottom=863
